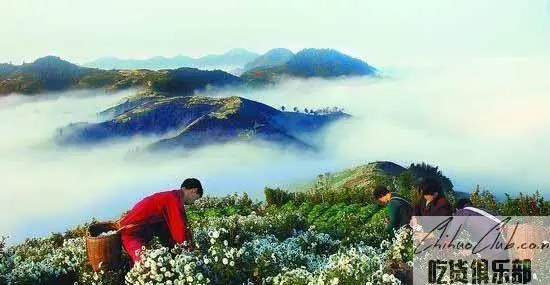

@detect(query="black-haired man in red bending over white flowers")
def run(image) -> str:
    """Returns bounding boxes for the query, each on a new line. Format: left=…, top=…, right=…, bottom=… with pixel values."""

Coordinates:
left=120, top=178, right=203, bottom=263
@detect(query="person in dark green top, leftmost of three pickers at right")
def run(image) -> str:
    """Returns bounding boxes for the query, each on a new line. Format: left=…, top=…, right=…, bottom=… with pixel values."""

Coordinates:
left=373, top=186, right=412, bottom=236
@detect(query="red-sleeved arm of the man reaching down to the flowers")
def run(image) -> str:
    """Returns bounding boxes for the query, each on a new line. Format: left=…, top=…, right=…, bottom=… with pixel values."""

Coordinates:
left=163, top=197, right=192, bottom=243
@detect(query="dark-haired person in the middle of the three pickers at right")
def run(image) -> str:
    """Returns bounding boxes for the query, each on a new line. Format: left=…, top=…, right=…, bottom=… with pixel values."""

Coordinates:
left=414, top=177, right=452, bottom=216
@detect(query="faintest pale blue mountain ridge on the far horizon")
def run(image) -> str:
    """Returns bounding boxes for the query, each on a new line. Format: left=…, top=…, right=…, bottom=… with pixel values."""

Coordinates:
left=84, top=49, right=259, bottom=72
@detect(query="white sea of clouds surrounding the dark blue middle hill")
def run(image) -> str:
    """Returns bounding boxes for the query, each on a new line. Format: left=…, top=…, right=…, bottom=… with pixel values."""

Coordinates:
left=0, top=58, right=550, bottom=243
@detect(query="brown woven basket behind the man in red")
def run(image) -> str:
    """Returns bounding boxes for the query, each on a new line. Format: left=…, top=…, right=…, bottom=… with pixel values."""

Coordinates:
left=86, top=222, right=122, bottom=271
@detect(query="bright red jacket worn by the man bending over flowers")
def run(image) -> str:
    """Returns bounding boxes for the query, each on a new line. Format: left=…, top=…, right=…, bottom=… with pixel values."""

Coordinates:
left=120, top=190, right=193, bottom=243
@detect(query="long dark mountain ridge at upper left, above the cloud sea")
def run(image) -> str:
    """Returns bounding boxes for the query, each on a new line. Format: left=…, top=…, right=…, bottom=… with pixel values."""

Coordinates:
left=0, top=56, right=242, bottom=95
